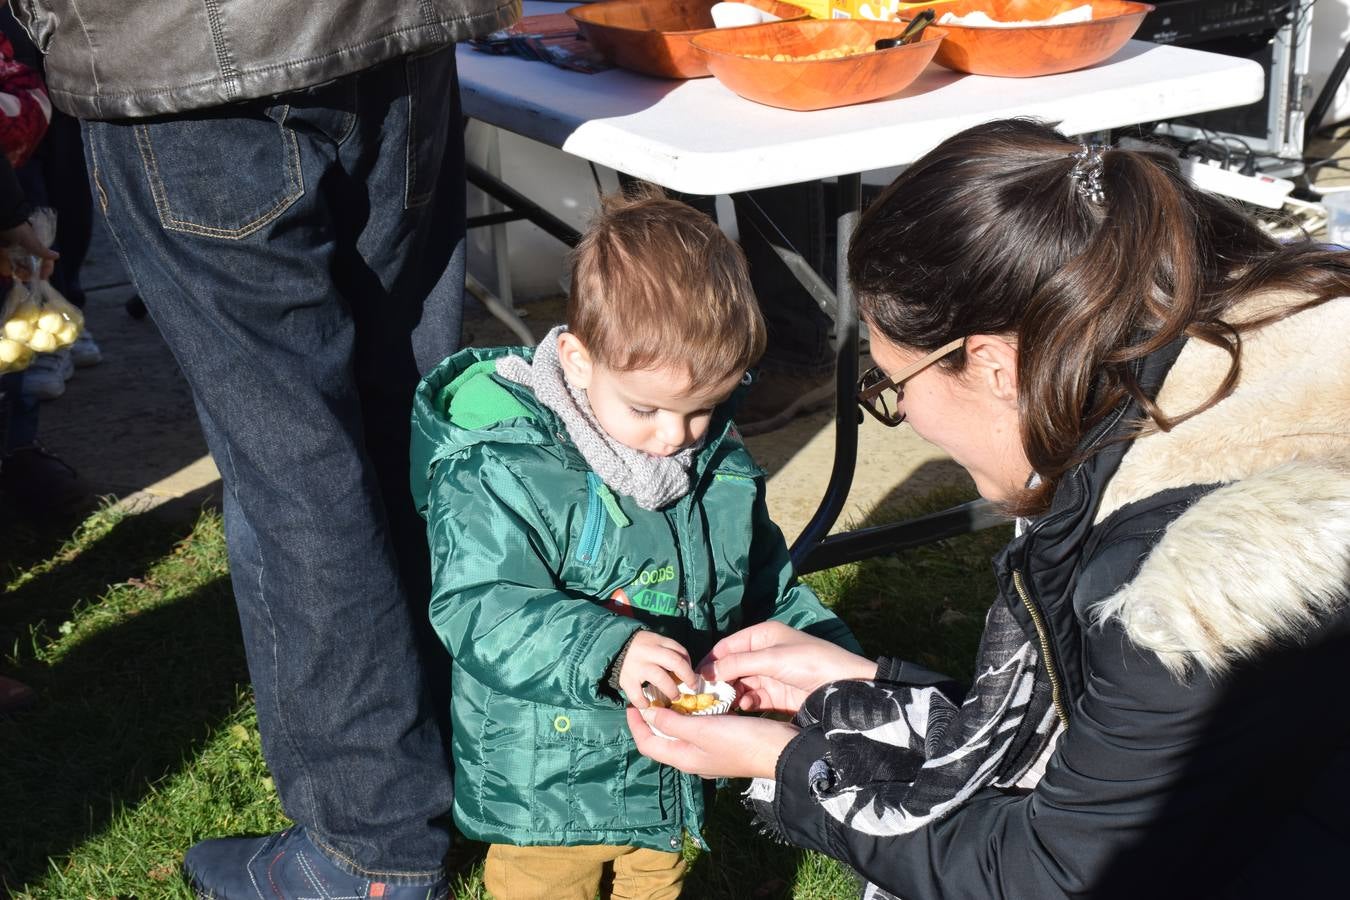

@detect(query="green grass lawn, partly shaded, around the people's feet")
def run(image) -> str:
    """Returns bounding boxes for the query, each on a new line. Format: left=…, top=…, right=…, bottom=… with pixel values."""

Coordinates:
left=0, top=488, right=1007, bottom=900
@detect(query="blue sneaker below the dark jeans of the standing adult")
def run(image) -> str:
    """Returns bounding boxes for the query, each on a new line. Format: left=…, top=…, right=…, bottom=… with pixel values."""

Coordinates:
left=182, top=826, right=450, bottom=900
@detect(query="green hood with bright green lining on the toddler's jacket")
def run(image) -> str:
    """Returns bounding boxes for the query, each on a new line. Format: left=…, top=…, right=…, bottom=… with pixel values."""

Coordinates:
left=412, top=347, right=556, bottom=510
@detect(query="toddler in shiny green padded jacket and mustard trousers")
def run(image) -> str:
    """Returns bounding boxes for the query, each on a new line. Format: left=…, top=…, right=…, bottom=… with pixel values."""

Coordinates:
left=413, top=186, right=857, bottom=900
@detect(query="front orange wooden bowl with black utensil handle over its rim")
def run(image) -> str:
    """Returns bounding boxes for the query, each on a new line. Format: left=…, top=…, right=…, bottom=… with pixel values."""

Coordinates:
left=693, top=19, right=945, bottom=111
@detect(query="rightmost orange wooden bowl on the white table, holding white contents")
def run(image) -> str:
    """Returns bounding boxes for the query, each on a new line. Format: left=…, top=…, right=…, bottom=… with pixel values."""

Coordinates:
left=937, top=0, right=1153, bottom=78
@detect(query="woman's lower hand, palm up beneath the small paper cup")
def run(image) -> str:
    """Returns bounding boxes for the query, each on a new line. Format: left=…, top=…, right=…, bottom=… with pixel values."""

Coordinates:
left=628, top=707, right=798, bottom=779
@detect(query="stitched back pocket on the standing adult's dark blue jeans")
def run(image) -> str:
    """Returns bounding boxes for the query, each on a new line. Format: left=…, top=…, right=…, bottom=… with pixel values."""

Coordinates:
left=135, top=105, right=305, bottom=240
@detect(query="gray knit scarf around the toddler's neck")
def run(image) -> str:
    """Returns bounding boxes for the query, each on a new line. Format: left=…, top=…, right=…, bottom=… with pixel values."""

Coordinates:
left=497, top=325, right=702, bottom=510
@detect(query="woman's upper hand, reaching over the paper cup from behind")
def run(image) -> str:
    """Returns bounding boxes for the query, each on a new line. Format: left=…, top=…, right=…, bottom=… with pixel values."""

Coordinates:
left=702, top=622, right=876, bottom=712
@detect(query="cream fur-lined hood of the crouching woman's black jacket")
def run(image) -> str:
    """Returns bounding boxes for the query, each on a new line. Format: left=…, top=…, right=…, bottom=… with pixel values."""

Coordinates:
left=1094, top=296, right=1350, bottom=673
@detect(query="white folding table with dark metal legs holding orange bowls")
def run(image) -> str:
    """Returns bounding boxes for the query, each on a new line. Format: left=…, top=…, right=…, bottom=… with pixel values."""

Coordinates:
left=458, top=0, right=1265, bottom=572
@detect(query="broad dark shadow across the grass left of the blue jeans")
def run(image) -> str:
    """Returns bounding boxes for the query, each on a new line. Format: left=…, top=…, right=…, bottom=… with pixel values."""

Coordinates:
left=0, top=569, right=248, bottom=896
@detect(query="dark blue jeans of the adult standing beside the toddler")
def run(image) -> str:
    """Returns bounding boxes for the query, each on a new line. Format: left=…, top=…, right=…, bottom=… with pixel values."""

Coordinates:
left=85, top=47, right=464, bottom=882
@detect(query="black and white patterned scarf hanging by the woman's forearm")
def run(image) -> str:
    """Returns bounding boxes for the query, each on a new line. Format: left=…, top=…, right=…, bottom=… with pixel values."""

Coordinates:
left=745, top=593, right=1056, bottom=900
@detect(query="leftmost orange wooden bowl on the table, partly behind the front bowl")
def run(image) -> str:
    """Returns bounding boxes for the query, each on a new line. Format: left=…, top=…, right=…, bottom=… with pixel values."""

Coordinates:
left=567, top=0, right=807, bottom=78
